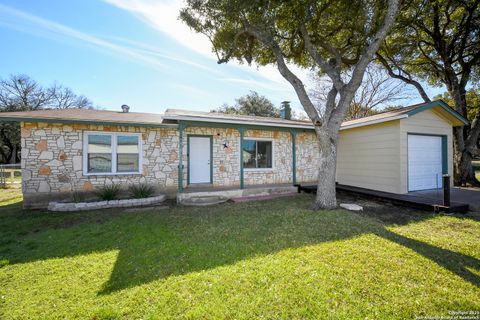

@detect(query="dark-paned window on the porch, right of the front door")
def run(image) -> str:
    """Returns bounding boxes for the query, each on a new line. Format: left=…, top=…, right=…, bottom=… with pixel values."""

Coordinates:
left=243, top=140, right=272, bottom=169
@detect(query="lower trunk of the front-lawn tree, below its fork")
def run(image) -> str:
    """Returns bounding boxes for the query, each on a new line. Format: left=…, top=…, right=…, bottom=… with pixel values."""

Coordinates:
left=312, top=128, right=338, bottom=210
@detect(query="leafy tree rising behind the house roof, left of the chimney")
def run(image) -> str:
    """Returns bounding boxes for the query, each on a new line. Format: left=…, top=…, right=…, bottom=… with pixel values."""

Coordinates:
left=212, top=91, right=280, bottom=118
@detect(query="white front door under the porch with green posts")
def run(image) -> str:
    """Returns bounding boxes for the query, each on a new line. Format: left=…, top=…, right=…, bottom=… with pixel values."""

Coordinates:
left=188, top=137, right=211, bottom=183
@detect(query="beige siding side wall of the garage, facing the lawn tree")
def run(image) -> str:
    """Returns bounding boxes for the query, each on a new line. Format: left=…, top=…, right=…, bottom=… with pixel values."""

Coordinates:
left=337, top=120, right=401, bottom=193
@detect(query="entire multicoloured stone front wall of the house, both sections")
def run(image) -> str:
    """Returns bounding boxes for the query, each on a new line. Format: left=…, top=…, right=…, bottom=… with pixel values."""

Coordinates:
left=21, top=122, right=318, bottom=207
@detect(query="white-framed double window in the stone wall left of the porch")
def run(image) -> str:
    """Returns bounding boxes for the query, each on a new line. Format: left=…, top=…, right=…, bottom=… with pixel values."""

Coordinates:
left=84, top=132, right=141, bottom=174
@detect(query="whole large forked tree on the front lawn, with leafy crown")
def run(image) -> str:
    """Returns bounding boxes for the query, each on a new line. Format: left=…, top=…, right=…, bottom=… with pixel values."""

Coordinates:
left=180, top=0, right=398, bottom=209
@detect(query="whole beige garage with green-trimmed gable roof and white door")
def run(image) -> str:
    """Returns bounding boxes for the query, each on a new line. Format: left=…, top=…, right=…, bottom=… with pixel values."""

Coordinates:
left=336, top=101, right=468, bottom=194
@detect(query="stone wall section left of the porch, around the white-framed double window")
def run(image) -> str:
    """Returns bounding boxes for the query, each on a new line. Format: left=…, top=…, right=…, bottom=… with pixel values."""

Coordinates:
left=21, top=123, right=178, bottom=207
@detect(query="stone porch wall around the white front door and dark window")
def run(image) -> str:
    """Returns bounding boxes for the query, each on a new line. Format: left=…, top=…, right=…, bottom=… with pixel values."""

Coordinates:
left=183, top=127, right=318, bottom=187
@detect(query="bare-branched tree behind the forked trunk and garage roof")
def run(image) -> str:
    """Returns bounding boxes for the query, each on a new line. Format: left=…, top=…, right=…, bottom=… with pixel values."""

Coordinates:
left=310, top=64, right=410, bottom=121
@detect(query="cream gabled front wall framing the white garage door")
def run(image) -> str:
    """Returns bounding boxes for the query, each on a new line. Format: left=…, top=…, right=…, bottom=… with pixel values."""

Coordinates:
left=400, top=109, right=453, bottom=193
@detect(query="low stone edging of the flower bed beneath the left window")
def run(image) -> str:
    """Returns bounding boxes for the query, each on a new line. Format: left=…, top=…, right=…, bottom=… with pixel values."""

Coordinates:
left=48, top=194, right=167, bottom=212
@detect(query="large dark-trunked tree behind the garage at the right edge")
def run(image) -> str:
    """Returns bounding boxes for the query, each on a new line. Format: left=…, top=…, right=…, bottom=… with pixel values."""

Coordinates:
left=377, top=0, right=480, bottom=185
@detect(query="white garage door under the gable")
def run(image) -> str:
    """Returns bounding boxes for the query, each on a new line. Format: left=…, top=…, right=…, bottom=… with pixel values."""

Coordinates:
left=408, top=134, right=442, bottom=191
